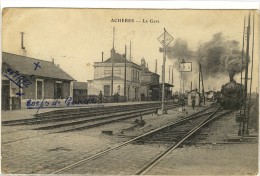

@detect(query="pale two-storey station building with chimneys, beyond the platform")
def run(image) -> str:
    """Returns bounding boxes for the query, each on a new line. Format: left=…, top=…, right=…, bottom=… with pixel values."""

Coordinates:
left=88, top=50, right=141, bottom=101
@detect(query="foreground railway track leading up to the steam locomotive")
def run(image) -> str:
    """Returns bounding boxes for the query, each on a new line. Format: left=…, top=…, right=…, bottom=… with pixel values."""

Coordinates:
left=52, top=107, right=230, bottom=175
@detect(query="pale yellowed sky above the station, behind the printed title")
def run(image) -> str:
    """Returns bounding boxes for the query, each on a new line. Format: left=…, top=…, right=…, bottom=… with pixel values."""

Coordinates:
left=2, top=8, right=259, bottom=91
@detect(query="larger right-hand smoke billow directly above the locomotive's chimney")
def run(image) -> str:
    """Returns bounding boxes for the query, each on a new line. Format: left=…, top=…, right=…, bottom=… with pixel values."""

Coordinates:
left=196, top=33, right=246, bottom=81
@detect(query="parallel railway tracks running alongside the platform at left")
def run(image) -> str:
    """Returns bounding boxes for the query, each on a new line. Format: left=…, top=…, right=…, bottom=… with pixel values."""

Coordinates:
left=2, top=102, right=178, bottom=144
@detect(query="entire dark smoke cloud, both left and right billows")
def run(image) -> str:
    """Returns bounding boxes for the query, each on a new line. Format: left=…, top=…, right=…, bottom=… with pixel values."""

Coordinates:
left=167, top=33, right=249, bottom=92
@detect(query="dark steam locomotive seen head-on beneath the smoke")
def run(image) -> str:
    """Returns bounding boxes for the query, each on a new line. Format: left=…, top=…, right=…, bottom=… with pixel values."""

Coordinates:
left=219, top=80, right=244, bottom=110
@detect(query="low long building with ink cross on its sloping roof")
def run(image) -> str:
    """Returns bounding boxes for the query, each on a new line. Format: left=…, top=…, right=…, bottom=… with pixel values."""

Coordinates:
left=2, top=52, right=74, bottom=110
